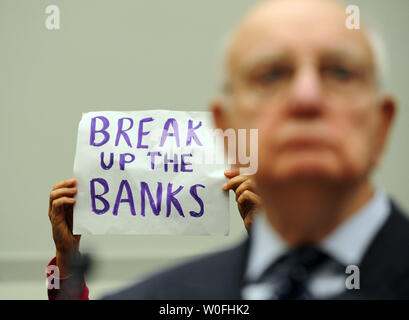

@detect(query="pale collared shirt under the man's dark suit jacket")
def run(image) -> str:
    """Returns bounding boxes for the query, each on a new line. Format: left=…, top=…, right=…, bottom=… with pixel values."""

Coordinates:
left=242, top=190, right=390, bottom=299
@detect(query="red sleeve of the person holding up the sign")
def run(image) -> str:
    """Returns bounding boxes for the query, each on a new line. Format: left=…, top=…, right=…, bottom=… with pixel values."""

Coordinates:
left=46, top=257, right=89, bottom=300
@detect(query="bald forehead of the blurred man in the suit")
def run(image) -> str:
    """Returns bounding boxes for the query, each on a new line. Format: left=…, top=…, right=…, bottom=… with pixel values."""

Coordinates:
left=228, top=0, right=372, bottom=69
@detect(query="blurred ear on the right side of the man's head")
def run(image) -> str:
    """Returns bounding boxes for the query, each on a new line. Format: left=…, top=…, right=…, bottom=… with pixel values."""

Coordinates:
left=376, top=96, right=397, bottom=162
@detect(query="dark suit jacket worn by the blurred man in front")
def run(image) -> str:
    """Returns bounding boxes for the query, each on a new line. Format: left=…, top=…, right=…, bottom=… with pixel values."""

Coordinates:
left=105, top=201, right=409, bottom=300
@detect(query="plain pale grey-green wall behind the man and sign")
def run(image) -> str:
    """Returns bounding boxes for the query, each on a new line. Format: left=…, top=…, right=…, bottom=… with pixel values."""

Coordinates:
left=0, top=0, right=409, bottom=299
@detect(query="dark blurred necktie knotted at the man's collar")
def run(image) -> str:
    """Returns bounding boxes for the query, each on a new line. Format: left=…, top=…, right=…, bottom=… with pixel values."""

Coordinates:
left=260, top=246, right=329, bottom=300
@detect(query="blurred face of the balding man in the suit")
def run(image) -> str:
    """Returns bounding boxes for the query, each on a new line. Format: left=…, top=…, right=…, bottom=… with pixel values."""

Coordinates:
left=217, top=1, right=392, bottom=185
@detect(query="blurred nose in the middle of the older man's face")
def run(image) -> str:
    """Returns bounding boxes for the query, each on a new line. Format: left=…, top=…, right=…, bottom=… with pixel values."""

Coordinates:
left=289, top=68, right=324, bottom=118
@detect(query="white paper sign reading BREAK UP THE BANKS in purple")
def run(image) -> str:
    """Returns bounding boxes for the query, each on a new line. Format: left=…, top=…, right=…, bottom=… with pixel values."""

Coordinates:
left=73, top=110, right=229, bottom=235
